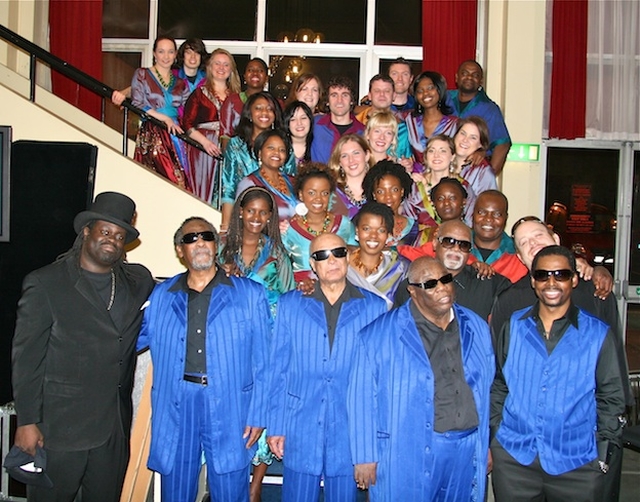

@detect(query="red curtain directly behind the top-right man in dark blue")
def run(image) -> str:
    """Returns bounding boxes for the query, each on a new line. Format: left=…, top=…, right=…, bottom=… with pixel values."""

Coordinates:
left=422, top=0, right=478, bottom=89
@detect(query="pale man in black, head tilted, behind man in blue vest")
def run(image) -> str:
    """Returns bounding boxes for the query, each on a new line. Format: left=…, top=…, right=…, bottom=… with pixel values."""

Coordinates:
left=490, top=216, right=635, bottom=502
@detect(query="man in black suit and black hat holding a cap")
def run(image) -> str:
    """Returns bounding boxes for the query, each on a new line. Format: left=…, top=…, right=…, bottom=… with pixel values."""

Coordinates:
left=12, top=192, right=153, bottom=502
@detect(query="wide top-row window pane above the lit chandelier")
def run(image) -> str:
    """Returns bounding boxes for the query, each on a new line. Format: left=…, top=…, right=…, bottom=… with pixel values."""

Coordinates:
left=266, top=0, right=367, bottom=44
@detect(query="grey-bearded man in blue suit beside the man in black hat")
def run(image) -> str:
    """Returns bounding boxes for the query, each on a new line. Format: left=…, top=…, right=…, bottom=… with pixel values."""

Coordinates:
left=138, top=217, right=270, bottom=502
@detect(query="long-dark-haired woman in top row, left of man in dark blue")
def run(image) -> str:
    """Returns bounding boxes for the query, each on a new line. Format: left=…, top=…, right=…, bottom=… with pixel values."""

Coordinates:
left=405, top=71, right=458, bottom=172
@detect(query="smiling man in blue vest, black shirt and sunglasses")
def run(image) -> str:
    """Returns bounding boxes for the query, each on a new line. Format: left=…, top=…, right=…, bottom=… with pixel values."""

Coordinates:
left=491, top=245, right=625, bottom=502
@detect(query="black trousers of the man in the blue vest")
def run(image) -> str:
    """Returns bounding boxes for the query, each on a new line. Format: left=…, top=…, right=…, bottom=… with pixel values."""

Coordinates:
left=491, top=439, right=605, bottom=502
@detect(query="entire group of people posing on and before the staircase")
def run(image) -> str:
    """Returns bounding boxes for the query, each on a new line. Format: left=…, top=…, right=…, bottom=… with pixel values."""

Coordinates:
left=8, top=37, right=632, bottom=502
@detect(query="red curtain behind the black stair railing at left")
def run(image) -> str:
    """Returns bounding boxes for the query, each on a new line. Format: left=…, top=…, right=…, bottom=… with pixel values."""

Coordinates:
left=49, top=0, right=102, bottom=119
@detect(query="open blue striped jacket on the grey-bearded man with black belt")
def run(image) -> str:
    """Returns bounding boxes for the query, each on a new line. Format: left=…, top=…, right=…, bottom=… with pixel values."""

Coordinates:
left=138, top=275, right=271, bottom=474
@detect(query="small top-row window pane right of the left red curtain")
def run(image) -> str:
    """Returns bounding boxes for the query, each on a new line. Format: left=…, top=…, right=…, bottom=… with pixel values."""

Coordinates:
left=102, top=0, right=149, bottom=38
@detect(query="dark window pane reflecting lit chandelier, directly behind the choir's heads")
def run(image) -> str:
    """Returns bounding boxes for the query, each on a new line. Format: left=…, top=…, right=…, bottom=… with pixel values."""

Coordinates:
left=269, top=56, right=360, bottom=104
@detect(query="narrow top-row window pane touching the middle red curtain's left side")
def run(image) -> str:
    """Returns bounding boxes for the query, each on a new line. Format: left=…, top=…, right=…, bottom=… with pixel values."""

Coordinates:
left=375, top=0, right=422, bottom=46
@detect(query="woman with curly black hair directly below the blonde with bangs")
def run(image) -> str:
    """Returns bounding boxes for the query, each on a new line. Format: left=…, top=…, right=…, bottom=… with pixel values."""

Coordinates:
left=362, top=160, right=419, bottom=247
